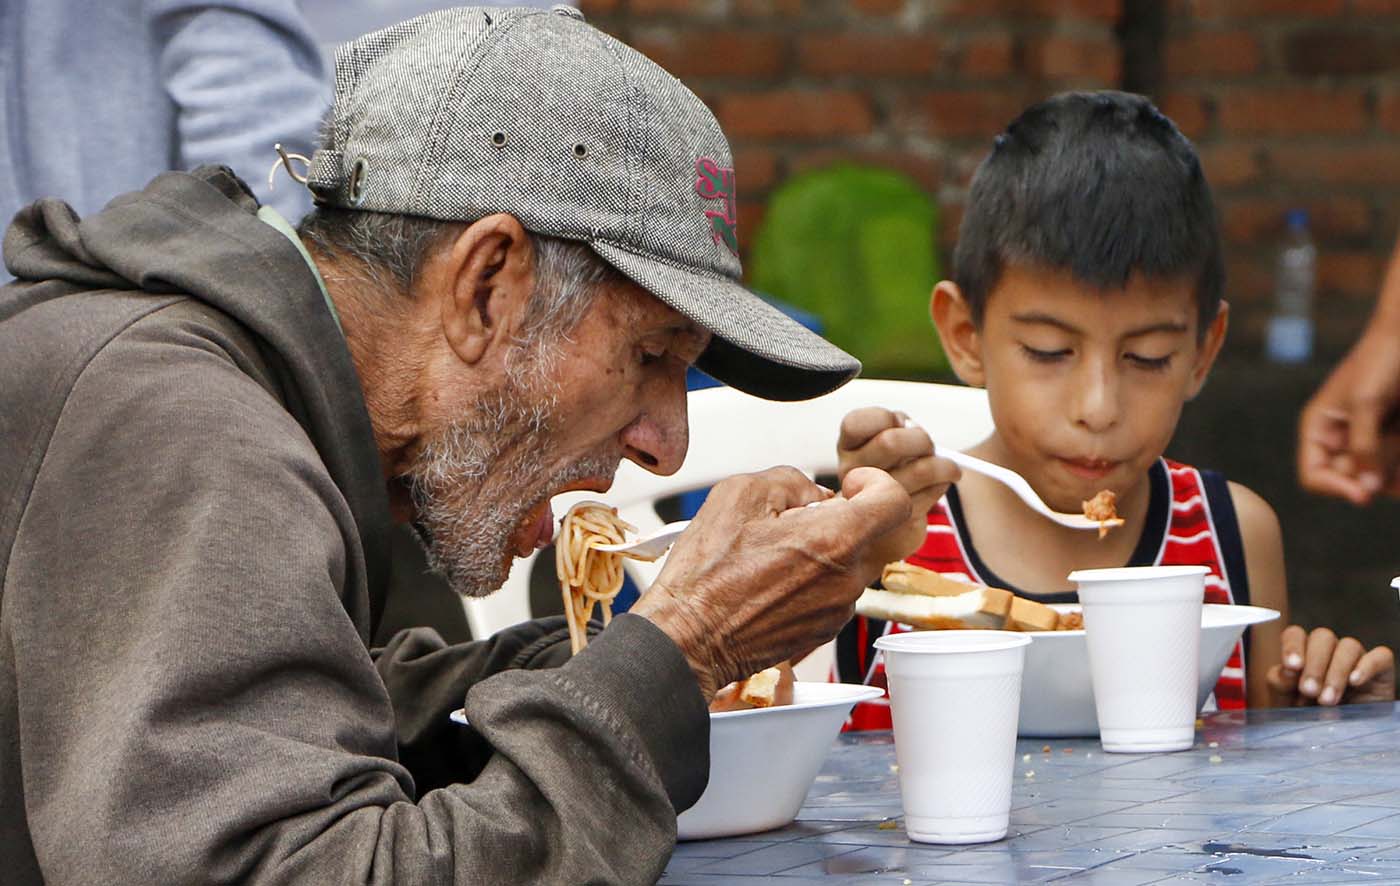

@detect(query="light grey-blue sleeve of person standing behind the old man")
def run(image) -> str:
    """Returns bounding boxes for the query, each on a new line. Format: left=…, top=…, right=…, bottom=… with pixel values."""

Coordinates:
left=144, top=0, right=330, bottom=224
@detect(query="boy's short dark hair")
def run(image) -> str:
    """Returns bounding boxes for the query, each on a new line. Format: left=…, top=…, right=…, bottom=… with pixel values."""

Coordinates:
left=953, top=91, right=1225, bottom=335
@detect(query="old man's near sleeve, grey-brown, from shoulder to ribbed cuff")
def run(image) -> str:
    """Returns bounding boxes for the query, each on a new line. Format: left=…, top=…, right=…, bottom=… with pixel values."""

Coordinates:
left=4, top=315, right=708, bottom=885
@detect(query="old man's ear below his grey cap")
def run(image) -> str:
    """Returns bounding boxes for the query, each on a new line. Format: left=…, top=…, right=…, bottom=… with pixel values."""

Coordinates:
left=420, top=213, right=535, bottom=364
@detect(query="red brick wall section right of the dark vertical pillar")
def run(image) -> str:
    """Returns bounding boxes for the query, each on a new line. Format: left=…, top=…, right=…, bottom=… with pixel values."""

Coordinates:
left=1158, top=0, right=1400, bottom=356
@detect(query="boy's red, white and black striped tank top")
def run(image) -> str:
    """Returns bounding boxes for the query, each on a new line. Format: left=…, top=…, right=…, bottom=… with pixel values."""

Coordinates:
left=836, top=459, right=1249, bottom=729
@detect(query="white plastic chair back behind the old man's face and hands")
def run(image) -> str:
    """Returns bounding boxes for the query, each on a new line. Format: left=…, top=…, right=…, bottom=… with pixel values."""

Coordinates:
left=466, top=378, right=993, bottom=679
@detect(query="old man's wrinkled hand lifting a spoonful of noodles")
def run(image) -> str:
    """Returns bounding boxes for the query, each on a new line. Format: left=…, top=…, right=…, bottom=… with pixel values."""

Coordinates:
left=631, top=467, right=909, bottom=701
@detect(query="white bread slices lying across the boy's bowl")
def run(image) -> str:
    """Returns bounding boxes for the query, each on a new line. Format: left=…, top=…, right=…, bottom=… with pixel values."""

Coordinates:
left=855, top=563, right=1084, bottom=631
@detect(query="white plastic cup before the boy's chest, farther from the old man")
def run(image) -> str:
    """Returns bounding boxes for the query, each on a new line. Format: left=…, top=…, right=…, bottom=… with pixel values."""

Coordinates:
left=1070, top=565, right=1210, bottom=753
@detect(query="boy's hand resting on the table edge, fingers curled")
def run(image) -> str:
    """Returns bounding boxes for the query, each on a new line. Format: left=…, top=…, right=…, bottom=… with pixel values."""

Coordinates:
left=1268, top=624, right=1396, bottom=707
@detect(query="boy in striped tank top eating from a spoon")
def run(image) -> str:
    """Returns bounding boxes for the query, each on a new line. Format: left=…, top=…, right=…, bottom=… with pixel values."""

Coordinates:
left=837, top=92, right=1394, bottom=728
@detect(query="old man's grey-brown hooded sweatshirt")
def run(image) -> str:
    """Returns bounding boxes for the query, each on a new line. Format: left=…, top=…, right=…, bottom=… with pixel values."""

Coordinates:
left=0, top=168, right=708, bottom=885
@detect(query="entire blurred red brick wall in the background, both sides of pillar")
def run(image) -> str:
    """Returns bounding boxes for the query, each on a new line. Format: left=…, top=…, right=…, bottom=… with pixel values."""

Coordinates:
left=581, top=0, right=1400, bottom=357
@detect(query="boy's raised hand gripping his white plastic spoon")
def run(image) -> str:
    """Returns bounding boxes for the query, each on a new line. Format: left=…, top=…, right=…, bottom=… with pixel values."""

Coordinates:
left=836, top=406, right=962, bottom=563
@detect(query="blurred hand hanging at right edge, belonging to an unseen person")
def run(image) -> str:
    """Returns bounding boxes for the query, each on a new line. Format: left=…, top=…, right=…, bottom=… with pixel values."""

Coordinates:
left=1298, top=329, right=1400, bottom=505
